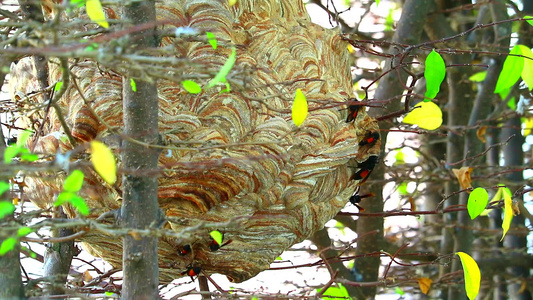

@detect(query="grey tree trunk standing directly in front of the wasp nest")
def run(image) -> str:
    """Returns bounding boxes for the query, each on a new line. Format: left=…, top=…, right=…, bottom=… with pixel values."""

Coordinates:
left=119, top=1, right=159, bottom=299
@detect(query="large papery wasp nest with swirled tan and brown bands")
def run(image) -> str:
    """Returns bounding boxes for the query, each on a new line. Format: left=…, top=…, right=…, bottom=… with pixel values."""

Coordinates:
left=12, top=0, right=379, bottom=282
